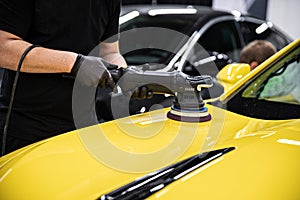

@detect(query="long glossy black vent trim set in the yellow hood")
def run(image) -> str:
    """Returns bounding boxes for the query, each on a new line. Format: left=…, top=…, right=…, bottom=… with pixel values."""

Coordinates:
left=99, top=147, right=235, bottom=200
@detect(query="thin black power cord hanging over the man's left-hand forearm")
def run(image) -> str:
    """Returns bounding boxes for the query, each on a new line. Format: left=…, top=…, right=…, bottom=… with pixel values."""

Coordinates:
left=1, top=44, right=39, bottom=156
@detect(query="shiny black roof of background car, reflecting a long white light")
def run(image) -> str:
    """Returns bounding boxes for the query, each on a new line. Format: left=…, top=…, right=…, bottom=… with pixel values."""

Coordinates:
left=121, top=5, right=234, bottom=35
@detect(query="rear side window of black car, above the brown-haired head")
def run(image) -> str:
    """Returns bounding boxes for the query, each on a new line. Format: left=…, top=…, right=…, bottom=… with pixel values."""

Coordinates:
left=239, top=22, right=290, bottom=50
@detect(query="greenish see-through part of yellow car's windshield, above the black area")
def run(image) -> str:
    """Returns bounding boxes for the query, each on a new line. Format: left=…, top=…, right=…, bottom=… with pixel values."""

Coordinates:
left=242, top=46, right=300, bottom=105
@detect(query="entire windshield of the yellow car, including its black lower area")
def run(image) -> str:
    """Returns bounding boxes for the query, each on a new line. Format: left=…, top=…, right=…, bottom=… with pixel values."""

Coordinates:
left=223, top=46, right=300, bottom=120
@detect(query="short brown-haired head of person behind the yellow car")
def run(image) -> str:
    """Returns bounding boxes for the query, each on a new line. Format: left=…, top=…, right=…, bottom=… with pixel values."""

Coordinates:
left=240, top=40, right=276, bottom=70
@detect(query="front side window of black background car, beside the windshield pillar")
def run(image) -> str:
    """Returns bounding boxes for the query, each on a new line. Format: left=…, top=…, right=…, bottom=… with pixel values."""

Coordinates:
left=179, top=21, right=241, bottom=76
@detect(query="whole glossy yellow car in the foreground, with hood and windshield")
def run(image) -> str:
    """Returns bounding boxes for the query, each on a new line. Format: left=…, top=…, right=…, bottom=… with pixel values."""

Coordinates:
left=0, top=40, right=300, bottom=200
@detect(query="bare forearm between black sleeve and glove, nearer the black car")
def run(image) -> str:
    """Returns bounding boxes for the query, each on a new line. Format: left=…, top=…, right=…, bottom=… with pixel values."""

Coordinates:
left=99, top=41, right=127, bottom=67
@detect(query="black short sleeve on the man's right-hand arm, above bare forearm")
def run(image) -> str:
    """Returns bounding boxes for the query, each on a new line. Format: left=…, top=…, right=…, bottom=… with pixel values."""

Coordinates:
left=102, top=1, right=121, bottom=42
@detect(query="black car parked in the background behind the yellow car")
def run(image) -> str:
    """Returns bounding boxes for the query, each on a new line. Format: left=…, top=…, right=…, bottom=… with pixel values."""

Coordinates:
left=120, top=5, right=292, bottom=73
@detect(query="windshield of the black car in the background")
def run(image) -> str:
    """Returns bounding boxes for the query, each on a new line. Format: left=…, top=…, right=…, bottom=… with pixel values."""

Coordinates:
left=120, top=11, right=199, bottom=65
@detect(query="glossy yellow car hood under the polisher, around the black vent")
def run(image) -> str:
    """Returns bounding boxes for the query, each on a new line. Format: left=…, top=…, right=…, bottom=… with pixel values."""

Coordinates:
left=0, top=105, right=300, bottom=200
